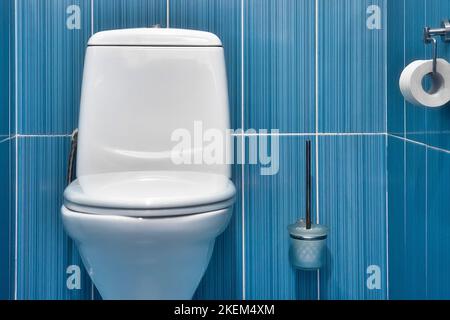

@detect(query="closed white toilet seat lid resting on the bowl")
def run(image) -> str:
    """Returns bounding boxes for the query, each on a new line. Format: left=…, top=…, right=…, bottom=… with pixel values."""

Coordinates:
left=64, top=171, right=236, bottom=216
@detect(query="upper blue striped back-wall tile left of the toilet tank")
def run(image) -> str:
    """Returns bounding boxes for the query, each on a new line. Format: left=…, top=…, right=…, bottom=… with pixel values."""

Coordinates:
left=17, top=0, right=91, bottom=134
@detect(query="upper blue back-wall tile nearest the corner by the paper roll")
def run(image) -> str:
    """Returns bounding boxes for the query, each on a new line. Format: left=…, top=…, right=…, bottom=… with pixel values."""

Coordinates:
left=318, top=0, right=387, bottom=132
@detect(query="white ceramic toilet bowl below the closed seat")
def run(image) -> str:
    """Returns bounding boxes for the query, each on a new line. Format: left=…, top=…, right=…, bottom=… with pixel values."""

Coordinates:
left=62, top=207, right=232, bottom=299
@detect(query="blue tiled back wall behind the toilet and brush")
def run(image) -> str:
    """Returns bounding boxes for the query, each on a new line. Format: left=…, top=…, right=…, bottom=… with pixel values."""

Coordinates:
left=0, top=0, right=392, bottom=299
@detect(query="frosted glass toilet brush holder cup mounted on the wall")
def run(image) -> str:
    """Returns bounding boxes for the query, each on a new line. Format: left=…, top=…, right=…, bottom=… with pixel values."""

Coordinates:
left=288, top=220, right=328, bottom=270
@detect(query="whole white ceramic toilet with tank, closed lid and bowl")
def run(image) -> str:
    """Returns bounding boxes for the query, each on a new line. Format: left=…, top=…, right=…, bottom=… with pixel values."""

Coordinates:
left=61, top=28, right=236, bottom=299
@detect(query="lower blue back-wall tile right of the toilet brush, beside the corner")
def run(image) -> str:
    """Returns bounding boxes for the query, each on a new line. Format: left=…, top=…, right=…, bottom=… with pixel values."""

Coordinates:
left=319, top=135, right=387, bottom=299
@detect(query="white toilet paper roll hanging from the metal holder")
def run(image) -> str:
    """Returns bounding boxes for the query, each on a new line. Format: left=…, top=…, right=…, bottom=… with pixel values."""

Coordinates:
left=400, top=59, right=450, bottom=107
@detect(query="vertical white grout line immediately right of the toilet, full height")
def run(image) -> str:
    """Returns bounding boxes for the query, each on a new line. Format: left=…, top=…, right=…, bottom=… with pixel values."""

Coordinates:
left=241, top=0, right=246, bottom=300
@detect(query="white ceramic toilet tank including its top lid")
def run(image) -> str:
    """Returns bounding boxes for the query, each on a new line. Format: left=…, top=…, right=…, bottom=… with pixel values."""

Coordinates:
left=77, top=28, right=230, bottom=176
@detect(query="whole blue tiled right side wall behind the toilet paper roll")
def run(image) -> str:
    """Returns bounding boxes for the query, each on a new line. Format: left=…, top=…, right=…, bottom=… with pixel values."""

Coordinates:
left=387, top=0, right=450, bottom=299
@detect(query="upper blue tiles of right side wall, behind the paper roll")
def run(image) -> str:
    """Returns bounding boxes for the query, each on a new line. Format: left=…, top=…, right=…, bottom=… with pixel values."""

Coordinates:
left=388, top=0, right=450, bottom=150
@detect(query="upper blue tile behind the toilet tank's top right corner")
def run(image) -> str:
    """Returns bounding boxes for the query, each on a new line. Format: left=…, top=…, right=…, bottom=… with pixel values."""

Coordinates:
left=170, top=0, right=242, bottom=129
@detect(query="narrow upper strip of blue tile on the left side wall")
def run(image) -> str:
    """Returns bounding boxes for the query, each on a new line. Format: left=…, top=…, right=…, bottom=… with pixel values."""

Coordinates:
left=0, top=1, right=14, bottom=136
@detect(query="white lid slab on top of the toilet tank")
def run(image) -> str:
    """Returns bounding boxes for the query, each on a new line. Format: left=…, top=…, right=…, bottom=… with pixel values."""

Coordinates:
left=88, top=28, right=222, bottom=47
